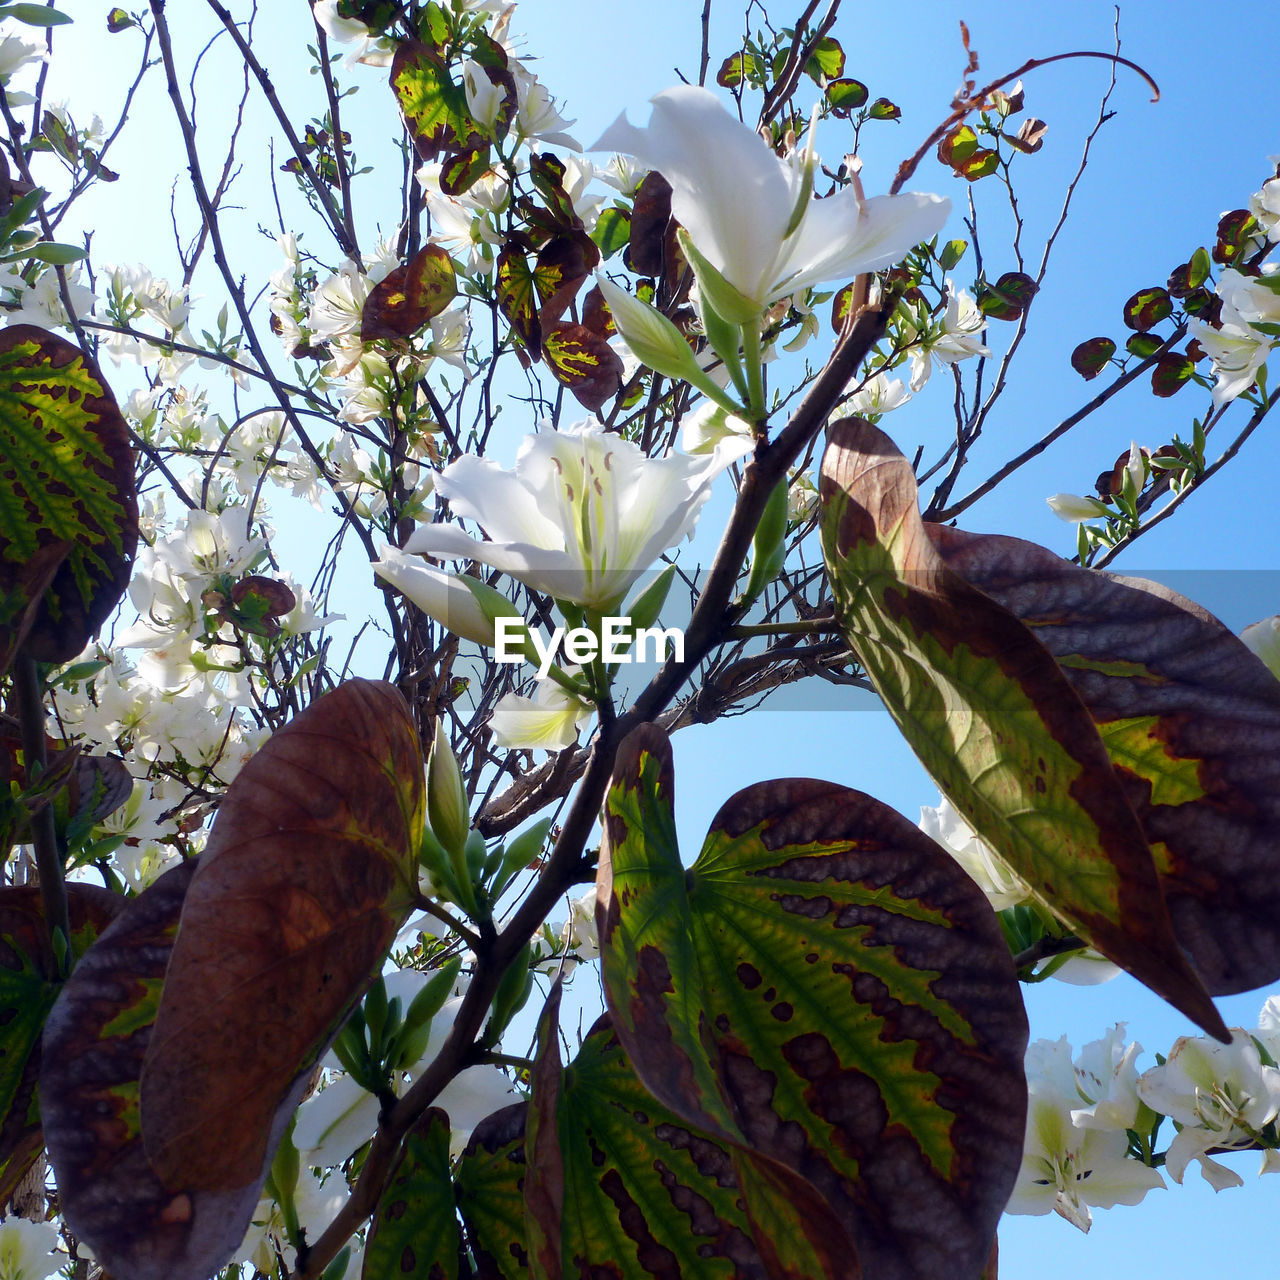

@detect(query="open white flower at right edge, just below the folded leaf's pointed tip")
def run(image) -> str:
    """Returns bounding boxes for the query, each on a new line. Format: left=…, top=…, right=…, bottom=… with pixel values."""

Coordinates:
left=1138, top=1028, right=1280, bottom=1190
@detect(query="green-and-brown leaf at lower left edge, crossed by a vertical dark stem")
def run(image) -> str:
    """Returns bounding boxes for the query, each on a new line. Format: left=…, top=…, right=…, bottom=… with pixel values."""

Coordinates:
left=0, top=884, right=124, bottom=1204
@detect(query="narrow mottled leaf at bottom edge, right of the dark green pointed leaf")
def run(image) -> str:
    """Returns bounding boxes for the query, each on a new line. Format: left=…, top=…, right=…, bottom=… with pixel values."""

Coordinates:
left=453, top=1102, right=529, bottom=1280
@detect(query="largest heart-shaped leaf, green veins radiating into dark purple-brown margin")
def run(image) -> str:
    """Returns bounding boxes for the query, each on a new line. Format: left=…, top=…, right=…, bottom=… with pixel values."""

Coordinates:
left=596, top=726, right=1027, bottom=1280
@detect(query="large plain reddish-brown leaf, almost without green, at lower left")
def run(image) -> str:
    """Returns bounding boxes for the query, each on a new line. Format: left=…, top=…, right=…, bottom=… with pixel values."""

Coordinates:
left=142, top=680, right=424, bottom=1190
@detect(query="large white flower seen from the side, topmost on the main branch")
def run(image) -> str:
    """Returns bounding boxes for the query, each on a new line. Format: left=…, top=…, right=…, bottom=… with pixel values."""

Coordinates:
left=591, top=84, right=951, bottom=320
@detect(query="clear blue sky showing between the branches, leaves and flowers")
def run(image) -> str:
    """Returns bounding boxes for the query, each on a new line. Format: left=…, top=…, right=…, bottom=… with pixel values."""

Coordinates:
left=37, top=0, right=1280, bottom=1280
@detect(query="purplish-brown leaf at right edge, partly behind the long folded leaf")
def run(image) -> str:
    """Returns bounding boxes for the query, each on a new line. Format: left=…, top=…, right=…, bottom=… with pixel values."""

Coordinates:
left=928, top=526, right=1280, bottom=995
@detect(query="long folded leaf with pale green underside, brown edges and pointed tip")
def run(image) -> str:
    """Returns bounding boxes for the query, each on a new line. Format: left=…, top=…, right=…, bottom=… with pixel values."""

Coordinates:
left=820, top=419, right=1226, bottom=1036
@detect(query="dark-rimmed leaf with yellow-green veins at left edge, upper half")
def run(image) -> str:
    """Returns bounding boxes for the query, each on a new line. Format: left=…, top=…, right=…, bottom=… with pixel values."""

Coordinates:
left=0, top=324, right=138, bottom=662
